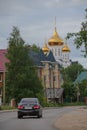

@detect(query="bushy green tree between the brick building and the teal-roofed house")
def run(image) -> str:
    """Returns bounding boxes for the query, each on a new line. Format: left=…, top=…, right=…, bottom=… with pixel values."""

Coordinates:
left=61, top=63, right=83, bottom=101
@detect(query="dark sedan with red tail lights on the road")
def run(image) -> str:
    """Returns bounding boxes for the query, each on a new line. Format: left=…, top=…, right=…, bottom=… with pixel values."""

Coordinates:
left=17, top=98, right=42, bottom=118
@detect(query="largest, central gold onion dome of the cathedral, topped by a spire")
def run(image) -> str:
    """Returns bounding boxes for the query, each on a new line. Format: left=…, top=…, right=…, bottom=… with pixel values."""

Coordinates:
left=48, top=27, right=64, bottom=46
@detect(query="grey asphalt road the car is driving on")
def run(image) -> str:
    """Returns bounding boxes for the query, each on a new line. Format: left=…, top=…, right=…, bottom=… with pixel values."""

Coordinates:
left=0, top=107, right=77, bottom=130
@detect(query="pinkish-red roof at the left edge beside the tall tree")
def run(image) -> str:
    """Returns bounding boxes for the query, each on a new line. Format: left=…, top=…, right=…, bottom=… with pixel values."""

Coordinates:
left=0, top=49, right=8, bottom=72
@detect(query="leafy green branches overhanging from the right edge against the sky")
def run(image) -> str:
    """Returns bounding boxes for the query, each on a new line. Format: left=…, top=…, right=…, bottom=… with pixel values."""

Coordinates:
left=66, top=9, right=87, bottom=57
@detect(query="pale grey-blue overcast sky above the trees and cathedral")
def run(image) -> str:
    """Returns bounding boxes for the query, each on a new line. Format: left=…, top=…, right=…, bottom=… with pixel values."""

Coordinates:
left=0, top=0, right=87, bottom=68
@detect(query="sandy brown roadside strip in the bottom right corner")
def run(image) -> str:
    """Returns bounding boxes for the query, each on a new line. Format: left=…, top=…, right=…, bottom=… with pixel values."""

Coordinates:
left=55, top=107, right=87, bottom=130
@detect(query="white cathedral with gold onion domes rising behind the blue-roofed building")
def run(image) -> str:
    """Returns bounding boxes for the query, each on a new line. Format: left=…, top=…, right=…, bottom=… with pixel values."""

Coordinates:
left=42, top=27, right=71, bottom=68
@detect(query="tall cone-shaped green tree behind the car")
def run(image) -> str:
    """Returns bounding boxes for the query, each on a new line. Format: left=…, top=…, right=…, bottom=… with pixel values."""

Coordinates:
left=6, top=27, right=43, bottom=102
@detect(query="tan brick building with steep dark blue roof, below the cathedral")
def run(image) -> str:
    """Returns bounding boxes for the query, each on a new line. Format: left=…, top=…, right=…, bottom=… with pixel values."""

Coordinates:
left=29, top=47, right=63, bottom=102
